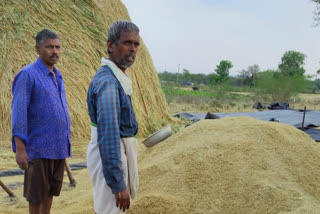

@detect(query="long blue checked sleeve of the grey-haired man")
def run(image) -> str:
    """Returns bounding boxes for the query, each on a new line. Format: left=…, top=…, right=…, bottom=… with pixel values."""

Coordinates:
left=97, top=81, right=126, bottom=193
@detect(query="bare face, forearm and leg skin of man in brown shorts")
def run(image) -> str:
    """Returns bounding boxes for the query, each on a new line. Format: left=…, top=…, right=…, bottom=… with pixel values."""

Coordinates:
left=14, top=39, right=60, bottom=214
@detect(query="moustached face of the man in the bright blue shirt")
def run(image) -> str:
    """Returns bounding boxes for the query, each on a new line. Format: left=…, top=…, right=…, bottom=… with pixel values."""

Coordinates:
left=36, top=39, right=60, bottom=67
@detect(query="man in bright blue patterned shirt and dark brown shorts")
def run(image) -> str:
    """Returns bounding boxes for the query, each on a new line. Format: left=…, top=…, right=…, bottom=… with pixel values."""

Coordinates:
left=11, top=29, right=71, bottom=214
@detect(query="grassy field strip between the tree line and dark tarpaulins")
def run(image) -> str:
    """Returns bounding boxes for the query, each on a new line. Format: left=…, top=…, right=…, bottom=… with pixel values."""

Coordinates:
left=162, top=84, right=320, bottom=114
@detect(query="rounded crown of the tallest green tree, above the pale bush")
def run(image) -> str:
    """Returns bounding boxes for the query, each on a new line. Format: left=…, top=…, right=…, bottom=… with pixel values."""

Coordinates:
left=279, top=51, right=306, bottom=76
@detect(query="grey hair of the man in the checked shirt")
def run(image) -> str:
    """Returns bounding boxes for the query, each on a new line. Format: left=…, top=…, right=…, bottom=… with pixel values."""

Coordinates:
left=108, top=20, right=139, bottom=43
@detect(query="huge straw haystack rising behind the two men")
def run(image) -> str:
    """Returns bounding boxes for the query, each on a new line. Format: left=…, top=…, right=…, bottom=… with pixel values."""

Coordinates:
left=0, top=0, right=170, bottom=140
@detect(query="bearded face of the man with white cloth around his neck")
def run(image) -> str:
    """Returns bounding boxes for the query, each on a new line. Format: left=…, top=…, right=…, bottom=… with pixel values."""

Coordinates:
left=108, top=31, right=140, bottom=71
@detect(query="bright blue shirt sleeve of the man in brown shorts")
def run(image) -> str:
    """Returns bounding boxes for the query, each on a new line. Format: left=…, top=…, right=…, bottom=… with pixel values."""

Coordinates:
left=11, top=70, right=33, bottom=152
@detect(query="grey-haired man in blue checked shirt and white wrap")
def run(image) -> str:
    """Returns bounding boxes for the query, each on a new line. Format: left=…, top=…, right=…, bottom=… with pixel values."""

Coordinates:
left=87, top=21, right=140, bottom=214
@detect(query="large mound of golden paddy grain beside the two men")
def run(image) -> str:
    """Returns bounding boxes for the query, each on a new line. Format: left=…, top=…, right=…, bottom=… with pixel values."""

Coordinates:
left=129, top=117, right=320, bottom=214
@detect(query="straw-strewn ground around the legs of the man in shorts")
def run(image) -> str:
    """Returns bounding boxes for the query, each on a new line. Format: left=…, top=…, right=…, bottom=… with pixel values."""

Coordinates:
left=0, top=139, right=146, bottom=214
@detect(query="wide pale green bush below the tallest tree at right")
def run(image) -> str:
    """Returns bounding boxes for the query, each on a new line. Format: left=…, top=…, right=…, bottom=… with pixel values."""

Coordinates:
left=256, top=70, right=310, bottom=102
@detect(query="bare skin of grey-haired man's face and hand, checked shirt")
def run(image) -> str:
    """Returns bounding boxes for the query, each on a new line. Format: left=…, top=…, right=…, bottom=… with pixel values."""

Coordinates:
left=107, top=31, right=140, bottom=212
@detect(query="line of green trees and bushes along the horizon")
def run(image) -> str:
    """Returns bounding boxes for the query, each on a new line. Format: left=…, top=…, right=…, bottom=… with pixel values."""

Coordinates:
left=159, top=50, right=320, bottom=100
